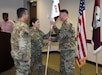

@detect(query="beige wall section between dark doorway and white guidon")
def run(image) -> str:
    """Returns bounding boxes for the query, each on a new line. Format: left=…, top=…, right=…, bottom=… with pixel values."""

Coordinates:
left=37, top=0, right=51, bottom=33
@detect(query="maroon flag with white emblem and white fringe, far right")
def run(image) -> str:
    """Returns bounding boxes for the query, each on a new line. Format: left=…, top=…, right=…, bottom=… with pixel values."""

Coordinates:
left=92, top=0, right=101, bottom=54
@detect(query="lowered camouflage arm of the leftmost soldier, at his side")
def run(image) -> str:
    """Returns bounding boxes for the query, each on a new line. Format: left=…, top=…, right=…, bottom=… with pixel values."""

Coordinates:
left=22, top=25, right=31, bottom=61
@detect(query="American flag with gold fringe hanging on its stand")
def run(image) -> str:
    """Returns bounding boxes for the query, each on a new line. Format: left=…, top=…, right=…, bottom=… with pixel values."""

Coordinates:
left=76, top=0, right=87, bottom=67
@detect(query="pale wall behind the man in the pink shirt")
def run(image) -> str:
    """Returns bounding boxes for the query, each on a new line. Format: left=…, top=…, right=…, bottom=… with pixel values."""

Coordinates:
left=0, top=0, right=24, bottom=20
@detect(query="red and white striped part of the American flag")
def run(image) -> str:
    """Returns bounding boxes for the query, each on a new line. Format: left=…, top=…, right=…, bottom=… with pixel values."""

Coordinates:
left=77, top=10, right=87, bottom=65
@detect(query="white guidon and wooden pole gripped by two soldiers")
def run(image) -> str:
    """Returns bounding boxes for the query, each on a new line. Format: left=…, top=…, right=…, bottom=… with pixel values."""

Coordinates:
left=45, top=0, right=59, bottom=75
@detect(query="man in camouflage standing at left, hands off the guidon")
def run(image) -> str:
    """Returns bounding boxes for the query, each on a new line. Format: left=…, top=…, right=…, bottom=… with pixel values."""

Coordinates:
left=11, top=8, right=31, bottom=75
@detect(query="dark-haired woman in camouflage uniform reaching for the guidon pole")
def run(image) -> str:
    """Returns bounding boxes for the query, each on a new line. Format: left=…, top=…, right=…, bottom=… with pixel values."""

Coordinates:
left=30, top=18, right=49, bottom=75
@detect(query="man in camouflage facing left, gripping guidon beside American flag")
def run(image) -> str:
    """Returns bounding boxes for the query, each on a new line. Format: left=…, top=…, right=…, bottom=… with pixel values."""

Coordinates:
left=51, top=9, right=76, bottom=75
